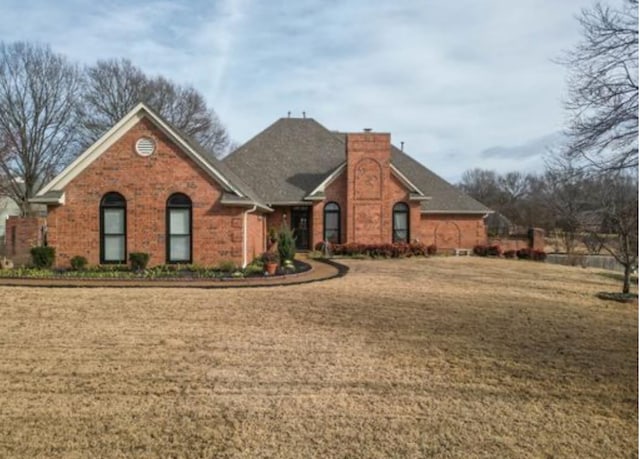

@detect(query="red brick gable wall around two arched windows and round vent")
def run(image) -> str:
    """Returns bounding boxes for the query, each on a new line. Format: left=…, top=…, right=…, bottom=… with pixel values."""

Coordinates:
left=47, top=118, right=258, bottom=266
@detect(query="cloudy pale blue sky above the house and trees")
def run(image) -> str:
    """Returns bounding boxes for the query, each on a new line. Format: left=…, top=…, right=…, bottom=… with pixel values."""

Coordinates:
left=0, top=0, right=592, bottom=181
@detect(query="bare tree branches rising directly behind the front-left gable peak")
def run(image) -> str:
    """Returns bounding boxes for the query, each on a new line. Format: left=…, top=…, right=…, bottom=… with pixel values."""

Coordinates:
left=82, top=59, right=229, bottom=156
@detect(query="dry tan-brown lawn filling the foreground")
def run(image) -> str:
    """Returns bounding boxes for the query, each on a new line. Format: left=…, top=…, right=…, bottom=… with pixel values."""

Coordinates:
left=0, top=257, right=638, bottom=458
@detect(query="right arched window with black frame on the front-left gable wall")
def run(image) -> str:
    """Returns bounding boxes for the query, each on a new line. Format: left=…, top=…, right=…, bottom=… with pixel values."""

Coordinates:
left=167, top=193, right=191, bottom=263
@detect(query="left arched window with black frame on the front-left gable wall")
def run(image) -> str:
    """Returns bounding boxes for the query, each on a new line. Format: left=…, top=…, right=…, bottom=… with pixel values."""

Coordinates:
left=100, top=193, right=127, bottom=263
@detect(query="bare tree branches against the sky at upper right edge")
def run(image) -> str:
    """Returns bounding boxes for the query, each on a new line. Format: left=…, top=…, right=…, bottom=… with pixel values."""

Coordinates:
left=560, top=0, right=638, bottom=171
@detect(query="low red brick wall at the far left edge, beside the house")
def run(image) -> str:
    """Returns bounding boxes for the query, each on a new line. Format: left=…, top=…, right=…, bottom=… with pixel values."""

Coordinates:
left=4, top=216, right=46, bottom=266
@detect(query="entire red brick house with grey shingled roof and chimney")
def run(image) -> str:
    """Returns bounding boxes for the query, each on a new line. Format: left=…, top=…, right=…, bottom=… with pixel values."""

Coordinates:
left=32, top=104, right=490, bottom=266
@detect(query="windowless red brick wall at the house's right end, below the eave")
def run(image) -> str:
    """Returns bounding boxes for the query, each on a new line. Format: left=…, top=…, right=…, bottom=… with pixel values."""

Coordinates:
left=416, top=214, right=487, bottom=250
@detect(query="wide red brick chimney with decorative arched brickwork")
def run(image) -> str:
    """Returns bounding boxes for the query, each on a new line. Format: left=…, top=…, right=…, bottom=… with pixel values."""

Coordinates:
left=346, top=130, right=391, bottom=244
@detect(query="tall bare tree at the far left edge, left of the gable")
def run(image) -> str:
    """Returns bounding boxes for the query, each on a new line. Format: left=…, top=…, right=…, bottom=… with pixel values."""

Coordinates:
left=0, top=42, right=81, bottom=215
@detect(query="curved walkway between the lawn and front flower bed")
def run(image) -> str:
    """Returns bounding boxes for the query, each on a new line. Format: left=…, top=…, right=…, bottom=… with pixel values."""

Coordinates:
left=0, top=258, right=349, bottom=288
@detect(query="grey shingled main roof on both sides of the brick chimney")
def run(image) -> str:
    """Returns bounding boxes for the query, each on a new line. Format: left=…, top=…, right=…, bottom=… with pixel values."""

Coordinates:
left=223, top=118, right=491, bottom=214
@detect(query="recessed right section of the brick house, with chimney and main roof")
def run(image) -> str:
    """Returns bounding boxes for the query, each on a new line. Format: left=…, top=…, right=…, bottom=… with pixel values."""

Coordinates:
left=224, top=113, right=492, bottom=250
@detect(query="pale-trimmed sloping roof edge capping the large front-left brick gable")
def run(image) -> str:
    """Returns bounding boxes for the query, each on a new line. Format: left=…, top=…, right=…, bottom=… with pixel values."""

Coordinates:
left=31, top=103, right=271, bottom=211
